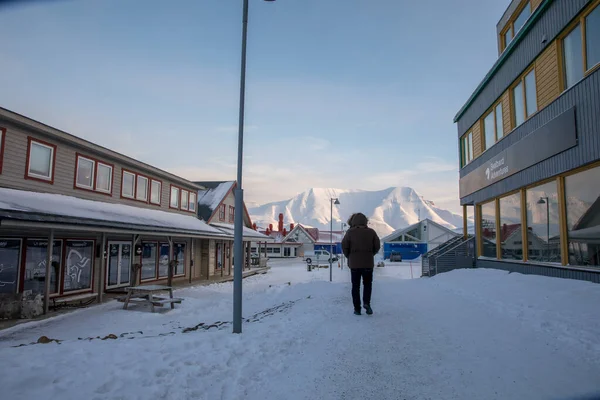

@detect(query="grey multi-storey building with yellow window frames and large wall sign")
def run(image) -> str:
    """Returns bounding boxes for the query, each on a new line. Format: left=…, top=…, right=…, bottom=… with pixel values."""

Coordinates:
left=454, top=0, right=600, bottom=282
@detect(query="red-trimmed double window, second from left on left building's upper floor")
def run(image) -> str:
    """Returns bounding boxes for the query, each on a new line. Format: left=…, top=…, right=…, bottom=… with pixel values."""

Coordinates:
left=74, top=153, right=115, bottom=196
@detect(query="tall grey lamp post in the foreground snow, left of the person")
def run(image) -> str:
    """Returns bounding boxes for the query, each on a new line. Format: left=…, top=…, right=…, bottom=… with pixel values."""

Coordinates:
left=233, top=0, right=275, bottom=333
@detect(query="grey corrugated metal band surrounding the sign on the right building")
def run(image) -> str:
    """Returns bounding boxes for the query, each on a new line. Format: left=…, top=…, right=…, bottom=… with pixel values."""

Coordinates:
left=460, top=70, right=600, bottom=204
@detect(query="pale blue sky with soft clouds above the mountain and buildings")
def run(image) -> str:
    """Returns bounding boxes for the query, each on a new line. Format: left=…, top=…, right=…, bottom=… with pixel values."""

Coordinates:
left=0, top=0, right=508, bottom=211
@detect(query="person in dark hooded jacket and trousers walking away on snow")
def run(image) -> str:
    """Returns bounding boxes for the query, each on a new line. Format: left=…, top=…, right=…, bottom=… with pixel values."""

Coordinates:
left=342, top=213, right=381, bottom=315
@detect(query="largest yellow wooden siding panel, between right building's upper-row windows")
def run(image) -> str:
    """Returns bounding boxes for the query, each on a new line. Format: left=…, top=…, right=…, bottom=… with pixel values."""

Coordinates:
left=535, top=42, right=560, bottom=109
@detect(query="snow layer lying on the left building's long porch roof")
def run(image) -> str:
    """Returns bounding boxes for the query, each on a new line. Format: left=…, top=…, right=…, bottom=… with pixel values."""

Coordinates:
left=0, top=188, right=229, bottom=237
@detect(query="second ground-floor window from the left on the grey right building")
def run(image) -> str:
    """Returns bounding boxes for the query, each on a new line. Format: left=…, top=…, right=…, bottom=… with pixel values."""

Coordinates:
left=499, top=193, right=523, bottom=260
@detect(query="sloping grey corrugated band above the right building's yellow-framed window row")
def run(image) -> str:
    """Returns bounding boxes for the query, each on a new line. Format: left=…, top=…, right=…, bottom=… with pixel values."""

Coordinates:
left=458, top=0, right=592, bottom=137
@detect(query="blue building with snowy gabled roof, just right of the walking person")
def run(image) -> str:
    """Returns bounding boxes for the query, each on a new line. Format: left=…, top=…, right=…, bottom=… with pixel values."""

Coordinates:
left=381, top=218, right=460, bottom=260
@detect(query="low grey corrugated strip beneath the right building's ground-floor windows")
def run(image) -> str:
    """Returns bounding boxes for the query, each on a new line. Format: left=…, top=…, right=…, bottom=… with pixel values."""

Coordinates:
left=477, top=259, right=600, bottom=283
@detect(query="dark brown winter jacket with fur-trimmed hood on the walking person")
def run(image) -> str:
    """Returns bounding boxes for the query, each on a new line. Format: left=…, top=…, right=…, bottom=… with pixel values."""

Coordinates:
left=342, top=213, right=381, bottom=269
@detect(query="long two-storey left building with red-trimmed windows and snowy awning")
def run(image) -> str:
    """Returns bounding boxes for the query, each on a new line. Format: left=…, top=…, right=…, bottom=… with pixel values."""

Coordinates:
left=0, top=109, right=258, bottom=318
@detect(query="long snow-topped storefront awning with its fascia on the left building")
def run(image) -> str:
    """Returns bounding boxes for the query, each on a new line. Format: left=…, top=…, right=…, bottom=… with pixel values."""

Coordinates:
left=0, top=188, right=231, bottom=238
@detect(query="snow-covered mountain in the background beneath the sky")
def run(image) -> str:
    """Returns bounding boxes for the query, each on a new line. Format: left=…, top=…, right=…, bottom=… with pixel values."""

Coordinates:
left=248, top=187, right=472, bottom=237
